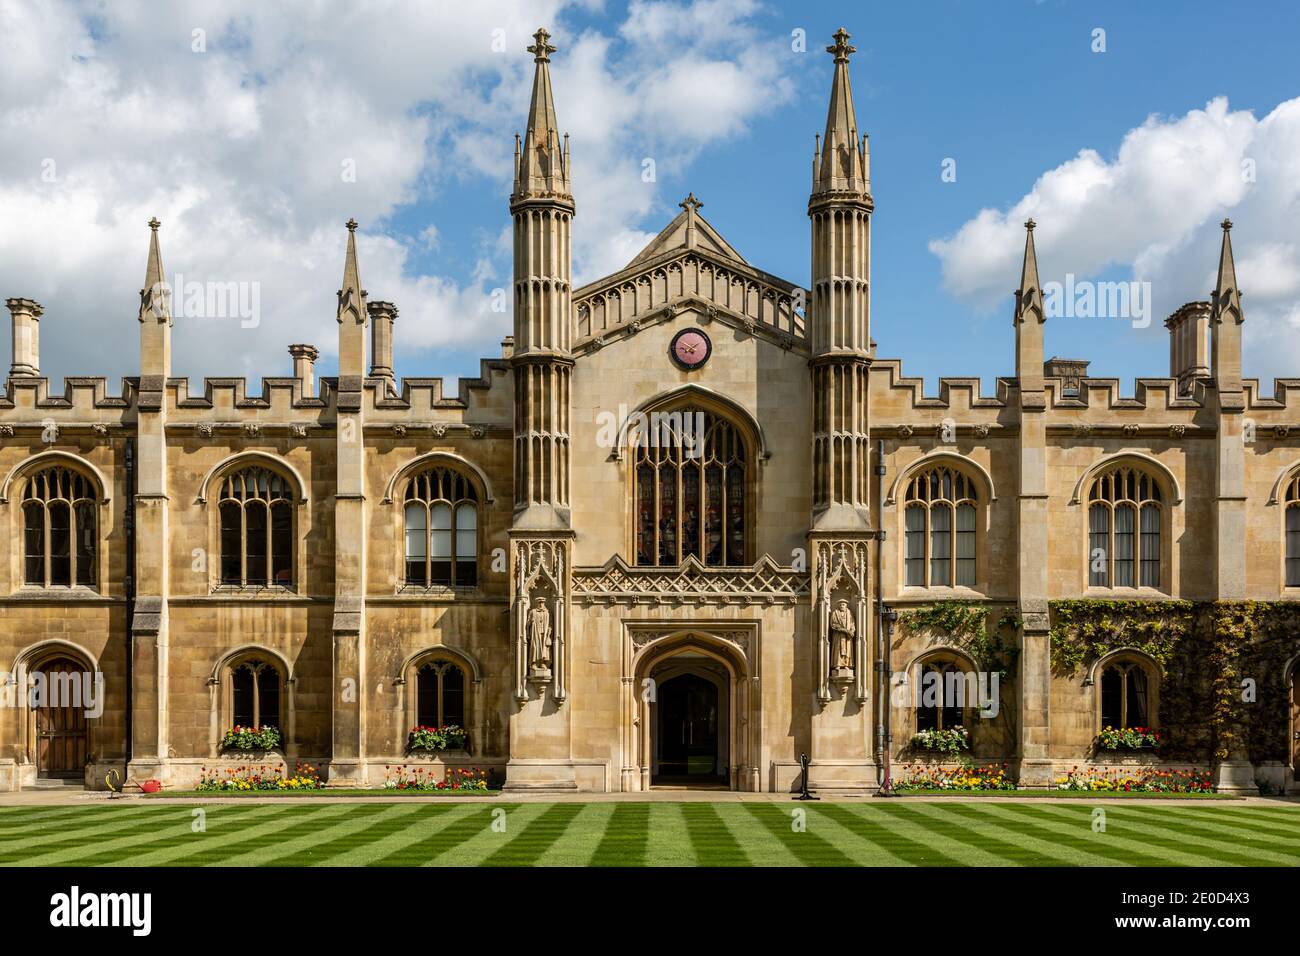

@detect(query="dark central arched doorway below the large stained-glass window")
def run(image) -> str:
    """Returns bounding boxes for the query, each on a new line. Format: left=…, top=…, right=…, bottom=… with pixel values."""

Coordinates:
left=650, top=671, right=729, bottom=787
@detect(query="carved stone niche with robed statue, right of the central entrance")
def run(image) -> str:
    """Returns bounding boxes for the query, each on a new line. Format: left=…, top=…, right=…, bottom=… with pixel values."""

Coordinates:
left=815, top=540, right=870, bottom=704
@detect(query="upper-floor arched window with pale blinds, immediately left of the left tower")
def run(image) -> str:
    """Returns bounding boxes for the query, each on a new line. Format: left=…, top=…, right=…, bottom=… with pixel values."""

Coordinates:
left=403, top=467, right=478, bottom=588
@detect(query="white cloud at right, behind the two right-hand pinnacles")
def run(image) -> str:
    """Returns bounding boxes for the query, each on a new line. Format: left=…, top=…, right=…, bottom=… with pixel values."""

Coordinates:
left=930, top=98, right=1300, bottom=378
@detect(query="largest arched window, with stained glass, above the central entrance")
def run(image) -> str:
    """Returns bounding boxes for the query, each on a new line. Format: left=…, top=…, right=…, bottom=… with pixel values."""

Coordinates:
left=633, top=408, right=749, bottom=567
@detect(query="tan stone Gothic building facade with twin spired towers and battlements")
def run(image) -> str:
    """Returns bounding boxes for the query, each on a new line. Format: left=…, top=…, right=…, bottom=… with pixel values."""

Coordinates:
left=0, top=30, right=1300, bottom=792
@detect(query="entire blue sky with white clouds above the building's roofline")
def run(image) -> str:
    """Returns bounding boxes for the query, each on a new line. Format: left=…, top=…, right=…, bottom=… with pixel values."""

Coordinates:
left=0, top=0, right=1300, bottom=392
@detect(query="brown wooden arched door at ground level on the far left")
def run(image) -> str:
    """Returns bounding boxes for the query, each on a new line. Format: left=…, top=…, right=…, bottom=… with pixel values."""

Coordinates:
left=30, top=656, right=95, bottom=779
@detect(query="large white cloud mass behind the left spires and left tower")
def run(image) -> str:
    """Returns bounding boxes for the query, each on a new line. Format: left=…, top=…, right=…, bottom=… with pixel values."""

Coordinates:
left=0, top=0, right=789, bottom=388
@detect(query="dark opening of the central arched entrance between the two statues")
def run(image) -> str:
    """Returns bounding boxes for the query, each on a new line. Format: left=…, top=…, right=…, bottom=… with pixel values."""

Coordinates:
left=653, top=674, right=727, bottom=787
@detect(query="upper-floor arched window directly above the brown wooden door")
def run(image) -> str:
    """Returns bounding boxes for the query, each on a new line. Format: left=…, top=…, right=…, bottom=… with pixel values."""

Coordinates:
left=22, top=467, right=99, bottom=588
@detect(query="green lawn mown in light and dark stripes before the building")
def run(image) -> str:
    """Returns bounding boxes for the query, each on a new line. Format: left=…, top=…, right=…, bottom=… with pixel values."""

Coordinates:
left=0, top=795, right=1300, bottom=866
